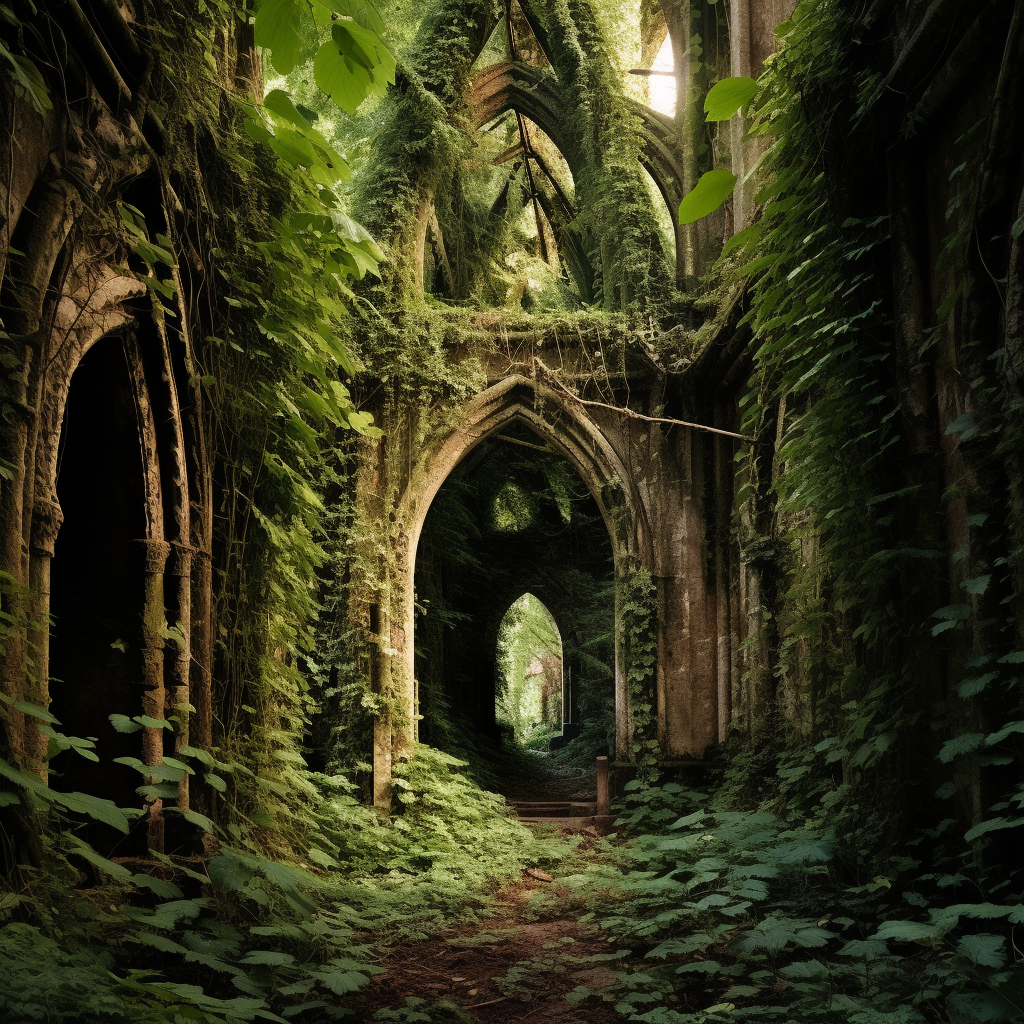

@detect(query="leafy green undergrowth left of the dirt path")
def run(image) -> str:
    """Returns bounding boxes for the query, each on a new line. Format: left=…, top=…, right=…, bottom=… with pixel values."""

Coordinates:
left=0, top=748, right=572, bottom=1024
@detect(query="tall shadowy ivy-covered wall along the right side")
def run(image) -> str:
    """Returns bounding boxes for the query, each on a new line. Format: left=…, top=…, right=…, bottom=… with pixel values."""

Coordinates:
left=708, top=4, right=1021, bottom=859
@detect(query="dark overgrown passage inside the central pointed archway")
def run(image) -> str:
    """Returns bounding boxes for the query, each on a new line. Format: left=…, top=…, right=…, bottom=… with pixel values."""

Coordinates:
left=415, top=413, right=615, bottom=782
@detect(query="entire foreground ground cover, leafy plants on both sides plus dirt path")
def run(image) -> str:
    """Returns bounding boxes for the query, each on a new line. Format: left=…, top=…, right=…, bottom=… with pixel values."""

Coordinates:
left=6, top=748, right=1024, bottom=1024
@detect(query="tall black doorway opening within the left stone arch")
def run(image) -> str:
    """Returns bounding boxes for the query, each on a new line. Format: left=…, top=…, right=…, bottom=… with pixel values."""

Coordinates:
left=50, top=338, right=145, bottom=845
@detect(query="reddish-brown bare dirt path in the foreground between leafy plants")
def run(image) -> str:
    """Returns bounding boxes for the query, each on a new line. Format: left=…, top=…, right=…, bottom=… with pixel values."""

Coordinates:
left=353, top=827, right=621, bottom=1024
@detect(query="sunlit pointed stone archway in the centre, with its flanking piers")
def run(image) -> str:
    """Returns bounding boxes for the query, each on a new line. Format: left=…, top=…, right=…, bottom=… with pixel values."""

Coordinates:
left=360, top=364, right=738, bottom=805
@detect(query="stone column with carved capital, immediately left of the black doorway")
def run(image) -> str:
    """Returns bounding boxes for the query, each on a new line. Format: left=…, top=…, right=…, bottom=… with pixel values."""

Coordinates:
left=25, top=496, right=68, bottom=778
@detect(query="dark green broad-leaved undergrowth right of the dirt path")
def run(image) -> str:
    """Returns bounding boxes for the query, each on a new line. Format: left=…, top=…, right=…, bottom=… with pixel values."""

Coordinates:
left=568, top=783, right=1024, bottom=1024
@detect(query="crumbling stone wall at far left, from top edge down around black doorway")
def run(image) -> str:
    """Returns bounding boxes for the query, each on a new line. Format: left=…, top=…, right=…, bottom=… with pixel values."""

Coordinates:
left=0, top=5, right=212, bottom=848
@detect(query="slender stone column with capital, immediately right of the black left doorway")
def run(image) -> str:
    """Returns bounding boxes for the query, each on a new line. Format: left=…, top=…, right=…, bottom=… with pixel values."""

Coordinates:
left=133, top=540, right=171, bottom=853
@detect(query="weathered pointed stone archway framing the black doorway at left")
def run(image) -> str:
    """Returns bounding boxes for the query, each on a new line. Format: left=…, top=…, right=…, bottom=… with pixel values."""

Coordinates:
left=3, top=172, right=212, bottom=849
